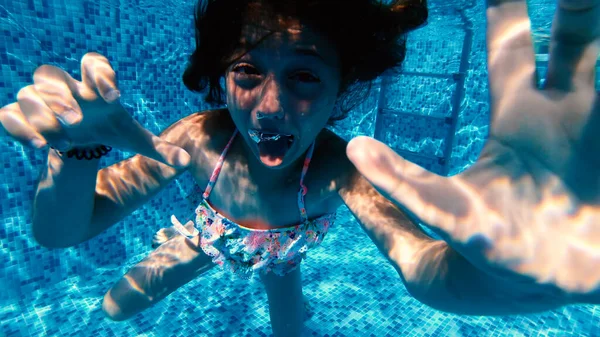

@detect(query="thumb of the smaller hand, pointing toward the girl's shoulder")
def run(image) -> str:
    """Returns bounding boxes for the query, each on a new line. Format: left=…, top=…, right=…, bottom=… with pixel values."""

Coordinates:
left=105, top=110, right=190, bottom=168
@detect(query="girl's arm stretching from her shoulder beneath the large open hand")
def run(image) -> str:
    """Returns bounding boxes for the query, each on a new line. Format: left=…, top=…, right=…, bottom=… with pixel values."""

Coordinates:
left=339, top=163, right=570, bottom=315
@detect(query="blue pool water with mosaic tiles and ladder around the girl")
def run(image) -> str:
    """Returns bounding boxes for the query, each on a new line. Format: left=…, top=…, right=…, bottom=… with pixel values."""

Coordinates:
left=0, top=0, right=600, bottom=337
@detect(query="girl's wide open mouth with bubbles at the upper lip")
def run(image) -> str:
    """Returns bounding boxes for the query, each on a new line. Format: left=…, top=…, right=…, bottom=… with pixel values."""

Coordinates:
left=248, top=129, right=295, bottom=166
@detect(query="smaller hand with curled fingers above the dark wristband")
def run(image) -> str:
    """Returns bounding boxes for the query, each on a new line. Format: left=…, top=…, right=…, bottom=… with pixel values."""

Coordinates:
left=0, top=52, right=190, bottom=168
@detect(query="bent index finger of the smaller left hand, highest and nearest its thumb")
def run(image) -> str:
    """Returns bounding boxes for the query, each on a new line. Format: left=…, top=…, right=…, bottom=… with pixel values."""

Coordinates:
left=77, top=52, right=121, bottom=103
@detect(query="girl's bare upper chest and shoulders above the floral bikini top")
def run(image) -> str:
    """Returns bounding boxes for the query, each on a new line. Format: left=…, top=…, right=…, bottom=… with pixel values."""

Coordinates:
left=192, top=134, right=341, bottom=229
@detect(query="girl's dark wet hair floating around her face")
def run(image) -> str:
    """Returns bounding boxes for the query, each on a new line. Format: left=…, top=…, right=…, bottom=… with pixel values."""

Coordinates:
left=183, top=0, right=428, bottom=124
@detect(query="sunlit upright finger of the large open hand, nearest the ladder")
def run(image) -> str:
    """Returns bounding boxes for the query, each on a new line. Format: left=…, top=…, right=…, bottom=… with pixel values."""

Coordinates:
left=486, top=0, right=535, bottom=102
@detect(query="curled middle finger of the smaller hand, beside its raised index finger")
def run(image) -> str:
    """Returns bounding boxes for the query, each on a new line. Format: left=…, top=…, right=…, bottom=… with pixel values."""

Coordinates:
left=33, top=65, right=83, bottom=127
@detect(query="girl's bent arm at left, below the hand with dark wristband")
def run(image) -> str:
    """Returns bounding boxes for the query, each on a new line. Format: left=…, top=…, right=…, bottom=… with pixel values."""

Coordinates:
left=33, top=114, right=203, bottom=248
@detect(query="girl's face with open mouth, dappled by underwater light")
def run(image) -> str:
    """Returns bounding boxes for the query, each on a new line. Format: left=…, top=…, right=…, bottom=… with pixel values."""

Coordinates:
left=225, top=20, right=341, bottom=169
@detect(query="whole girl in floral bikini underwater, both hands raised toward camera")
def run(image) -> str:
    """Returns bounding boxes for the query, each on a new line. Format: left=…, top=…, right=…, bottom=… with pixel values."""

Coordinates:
left=0, top=0, right=600, bottom=336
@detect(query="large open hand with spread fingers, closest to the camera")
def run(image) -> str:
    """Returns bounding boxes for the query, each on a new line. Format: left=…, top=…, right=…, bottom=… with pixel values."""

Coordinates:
left=348, top=0, right=600, bottom=301
